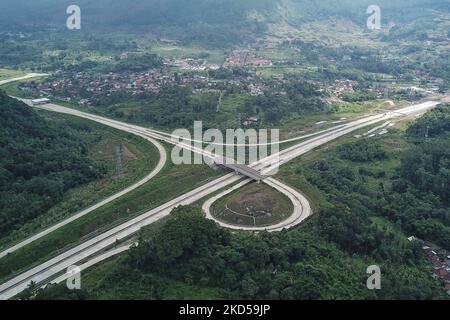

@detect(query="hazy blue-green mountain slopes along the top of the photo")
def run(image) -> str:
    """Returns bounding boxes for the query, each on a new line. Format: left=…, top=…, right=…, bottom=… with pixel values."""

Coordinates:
left=0, top=0, right=450, bottom=32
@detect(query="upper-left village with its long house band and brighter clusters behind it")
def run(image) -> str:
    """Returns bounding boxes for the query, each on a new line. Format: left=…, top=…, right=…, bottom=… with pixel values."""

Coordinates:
left=19, top=51, right=278, bottom=105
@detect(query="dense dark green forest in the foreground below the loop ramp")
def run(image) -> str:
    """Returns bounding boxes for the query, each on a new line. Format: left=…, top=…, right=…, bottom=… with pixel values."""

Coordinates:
left=31, top=207, right=443, bottom=299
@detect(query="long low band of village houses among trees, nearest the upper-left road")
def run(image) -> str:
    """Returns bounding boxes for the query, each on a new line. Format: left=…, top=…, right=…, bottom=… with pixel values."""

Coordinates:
left=20, top=61, right=267, bottom=105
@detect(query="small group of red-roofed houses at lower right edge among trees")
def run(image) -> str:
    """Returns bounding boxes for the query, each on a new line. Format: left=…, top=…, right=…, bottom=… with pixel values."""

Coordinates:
left=408, top=237, right=450, bottom=295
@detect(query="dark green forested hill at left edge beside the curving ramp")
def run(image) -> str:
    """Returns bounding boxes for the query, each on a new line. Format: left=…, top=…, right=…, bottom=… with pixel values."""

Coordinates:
left=0, top=91, right=100, bottom=235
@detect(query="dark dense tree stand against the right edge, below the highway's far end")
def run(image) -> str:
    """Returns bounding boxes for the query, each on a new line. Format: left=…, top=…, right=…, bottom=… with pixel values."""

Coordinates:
left=384, top=104, right=450, bottom=248
